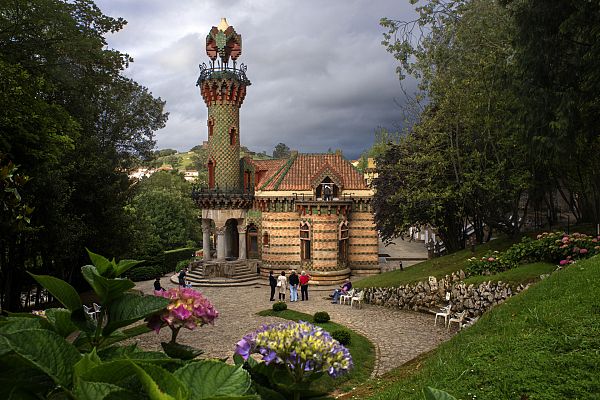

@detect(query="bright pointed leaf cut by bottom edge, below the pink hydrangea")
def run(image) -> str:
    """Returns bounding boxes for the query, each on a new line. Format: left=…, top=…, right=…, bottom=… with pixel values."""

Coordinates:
left=132, top=363, right=188, bottom=400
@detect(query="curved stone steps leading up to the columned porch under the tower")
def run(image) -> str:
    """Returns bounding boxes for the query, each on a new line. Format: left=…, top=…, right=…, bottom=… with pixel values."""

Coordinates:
left=176, top=260, right=261, bottom=287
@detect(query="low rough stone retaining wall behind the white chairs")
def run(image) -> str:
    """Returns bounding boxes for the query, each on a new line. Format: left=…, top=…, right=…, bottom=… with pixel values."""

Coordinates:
left=365, top=271, right=529, bottom=317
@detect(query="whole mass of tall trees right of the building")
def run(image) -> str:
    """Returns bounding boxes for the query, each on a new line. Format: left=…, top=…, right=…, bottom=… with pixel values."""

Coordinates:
left=374, top=0, right=600, bottom=250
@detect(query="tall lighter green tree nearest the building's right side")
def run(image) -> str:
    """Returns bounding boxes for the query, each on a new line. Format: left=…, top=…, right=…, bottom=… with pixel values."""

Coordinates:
left=374, top=0, right=530, bottom=250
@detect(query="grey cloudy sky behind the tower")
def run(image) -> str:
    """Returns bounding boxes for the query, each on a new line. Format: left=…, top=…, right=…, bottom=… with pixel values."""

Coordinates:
left=96, top=0, right=420, bottom=158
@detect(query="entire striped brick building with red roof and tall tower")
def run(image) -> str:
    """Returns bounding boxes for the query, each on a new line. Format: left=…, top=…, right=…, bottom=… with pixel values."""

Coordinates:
left=193, top=19, right=380, bottom=284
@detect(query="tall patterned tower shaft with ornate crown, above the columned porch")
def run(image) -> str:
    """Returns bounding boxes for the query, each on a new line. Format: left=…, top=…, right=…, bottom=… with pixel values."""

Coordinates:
left=197, top=18, right=250, bottom=193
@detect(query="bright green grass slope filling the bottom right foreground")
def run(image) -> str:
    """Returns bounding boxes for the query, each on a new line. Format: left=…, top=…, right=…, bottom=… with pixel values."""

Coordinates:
left=354, top=257, right=600, bottom=400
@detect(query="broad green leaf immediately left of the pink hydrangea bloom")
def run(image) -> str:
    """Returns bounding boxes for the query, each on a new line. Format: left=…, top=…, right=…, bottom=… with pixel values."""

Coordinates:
left=103, top=293, right=169, bottom=335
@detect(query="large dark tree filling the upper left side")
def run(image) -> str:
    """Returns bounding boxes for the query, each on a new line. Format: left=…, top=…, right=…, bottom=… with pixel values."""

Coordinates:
left=0, top=0, right=167, bottom=310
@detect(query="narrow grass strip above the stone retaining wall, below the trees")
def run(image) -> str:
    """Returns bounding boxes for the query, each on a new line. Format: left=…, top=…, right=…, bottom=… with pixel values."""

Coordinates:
left=353, top=238, right=520, bottom=288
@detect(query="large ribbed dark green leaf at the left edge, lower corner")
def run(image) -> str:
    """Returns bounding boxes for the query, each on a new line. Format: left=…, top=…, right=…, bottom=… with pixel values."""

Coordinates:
left=4, top=329, right=81, bottom=387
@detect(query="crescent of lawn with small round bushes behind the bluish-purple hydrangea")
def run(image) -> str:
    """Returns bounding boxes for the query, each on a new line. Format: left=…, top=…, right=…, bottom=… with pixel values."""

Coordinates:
left=258, top=310, right=375, bottom=392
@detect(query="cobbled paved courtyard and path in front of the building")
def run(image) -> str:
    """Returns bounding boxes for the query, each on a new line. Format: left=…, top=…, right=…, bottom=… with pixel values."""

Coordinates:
left=136, top=277, right=451, bottom=376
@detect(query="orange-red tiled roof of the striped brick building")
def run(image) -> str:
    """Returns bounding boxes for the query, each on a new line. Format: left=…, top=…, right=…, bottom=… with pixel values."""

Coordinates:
left=253, top=154, right=368, bottom=190
